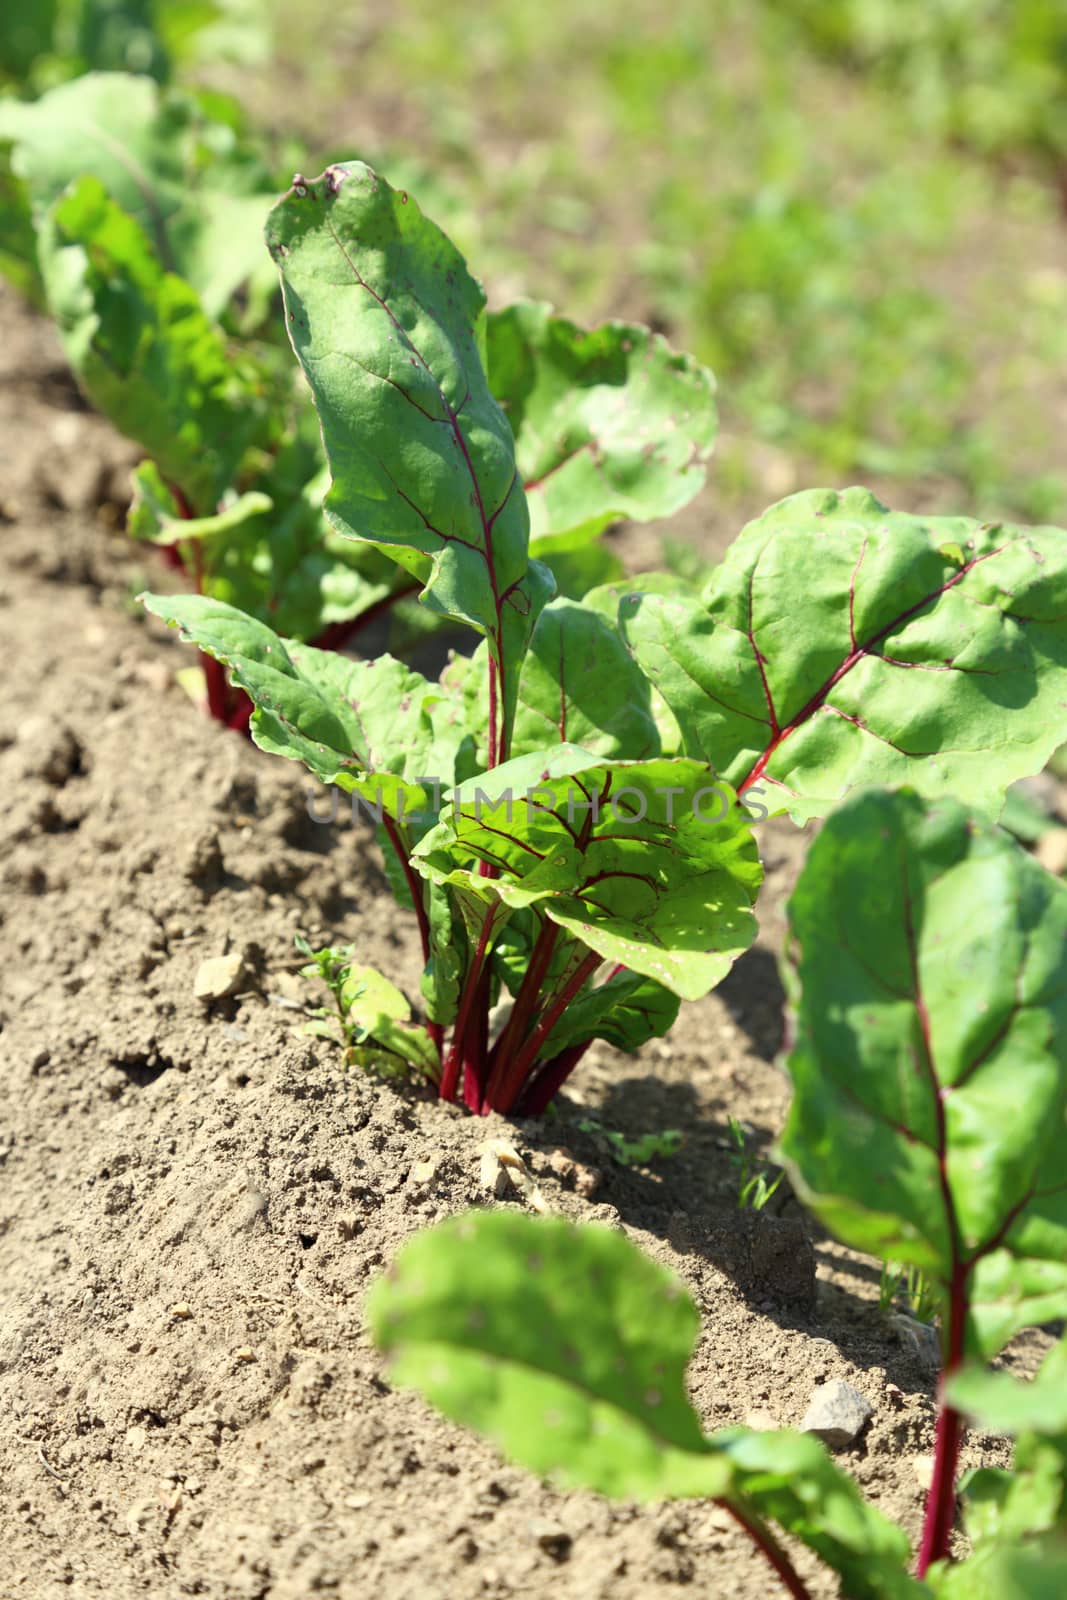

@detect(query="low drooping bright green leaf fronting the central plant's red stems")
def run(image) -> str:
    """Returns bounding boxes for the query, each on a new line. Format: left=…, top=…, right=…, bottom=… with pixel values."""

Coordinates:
left=413, top=744, right=761, bottom=1000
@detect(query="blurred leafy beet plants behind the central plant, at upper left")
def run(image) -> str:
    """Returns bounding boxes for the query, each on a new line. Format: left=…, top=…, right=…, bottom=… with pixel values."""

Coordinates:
left=0, top=72, right=385, bottom=722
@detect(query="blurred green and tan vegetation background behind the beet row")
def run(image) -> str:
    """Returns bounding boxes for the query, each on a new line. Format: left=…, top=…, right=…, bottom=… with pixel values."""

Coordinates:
left=0, top=0, right=1067, bottom=544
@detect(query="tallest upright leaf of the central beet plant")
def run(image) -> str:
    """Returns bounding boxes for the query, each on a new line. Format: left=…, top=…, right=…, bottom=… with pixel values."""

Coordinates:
left=267, top=162, right=552, bottom=745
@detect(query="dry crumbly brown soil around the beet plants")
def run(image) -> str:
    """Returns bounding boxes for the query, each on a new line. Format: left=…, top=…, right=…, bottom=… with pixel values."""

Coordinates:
left=0, top=288, right=1041, bottom=1600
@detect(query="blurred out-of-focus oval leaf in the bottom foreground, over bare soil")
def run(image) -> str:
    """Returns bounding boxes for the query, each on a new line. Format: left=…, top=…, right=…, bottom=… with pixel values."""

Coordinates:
left=375, top=1211, right=928, bottom=1600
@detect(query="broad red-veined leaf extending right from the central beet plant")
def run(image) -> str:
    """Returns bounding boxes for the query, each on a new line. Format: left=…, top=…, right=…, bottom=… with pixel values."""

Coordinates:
left=622, top=490, right=1067, bottom=821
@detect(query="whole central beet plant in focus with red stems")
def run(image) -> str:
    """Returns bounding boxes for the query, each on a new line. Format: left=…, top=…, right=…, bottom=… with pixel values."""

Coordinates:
left=146, top=163, right=1067, bottom=1114
